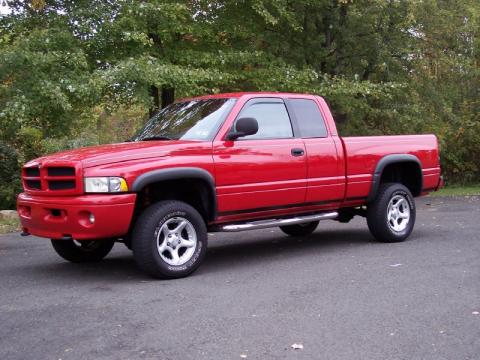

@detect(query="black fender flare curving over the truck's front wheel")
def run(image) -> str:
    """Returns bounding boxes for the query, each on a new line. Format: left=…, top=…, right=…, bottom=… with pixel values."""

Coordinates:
left=131, top=167, right=217, bottom=220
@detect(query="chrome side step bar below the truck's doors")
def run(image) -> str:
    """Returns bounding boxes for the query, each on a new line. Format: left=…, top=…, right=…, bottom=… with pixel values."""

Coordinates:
left=220, top=211, right=338, bottom=232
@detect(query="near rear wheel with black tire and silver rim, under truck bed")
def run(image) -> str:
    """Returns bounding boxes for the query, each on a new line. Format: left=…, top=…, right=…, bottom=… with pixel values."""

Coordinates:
left=367, top=183, right=416, bottom=243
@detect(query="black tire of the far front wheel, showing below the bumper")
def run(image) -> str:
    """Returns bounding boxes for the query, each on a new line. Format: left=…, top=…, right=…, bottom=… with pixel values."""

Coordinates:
left=52, top=239, right=115, bottom=263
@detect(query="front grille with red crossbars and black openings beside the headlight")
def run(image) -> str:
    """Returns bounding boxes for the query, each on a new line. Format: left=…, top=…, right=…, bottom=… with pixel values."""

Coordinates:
left=23, top=165, right=77, bottom=194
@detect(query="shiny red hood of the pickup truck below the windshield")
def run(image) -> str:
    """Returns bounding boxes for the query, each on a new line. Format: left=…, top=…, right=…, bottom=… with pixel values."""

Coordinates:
left=26, top=140, right=211, bottom=168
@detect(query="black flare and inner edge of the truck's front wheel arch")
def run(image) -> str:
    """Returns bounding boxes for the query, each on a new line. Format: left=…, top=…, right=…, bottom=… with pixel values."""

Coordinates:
left=131, top=167, right=217, bottom=222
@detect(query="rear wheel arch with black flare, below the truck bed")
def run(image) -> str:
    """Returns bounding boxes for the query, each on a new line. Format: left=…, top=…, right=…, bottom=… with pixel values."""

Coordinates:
left=367, top=154, right=423, bottom=202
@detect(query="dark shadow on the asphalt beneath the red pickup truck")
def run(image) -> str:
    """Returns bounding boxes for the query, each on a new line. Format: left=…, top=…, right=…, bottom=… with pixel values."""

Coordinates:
left=17, top=229, right=422, bottom=283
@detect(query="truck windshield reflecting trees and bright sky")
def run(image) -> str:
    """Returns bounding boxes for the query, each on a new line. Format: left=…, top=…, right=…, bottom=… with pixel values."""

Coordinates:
left=132, top=99, right=235, bottom=141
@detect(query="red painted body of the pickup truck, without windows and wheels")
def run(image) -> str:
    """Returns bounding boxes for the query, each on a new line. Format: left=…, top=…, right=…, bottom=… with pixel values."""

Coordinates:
left=18, top=93, right=440, bottom=239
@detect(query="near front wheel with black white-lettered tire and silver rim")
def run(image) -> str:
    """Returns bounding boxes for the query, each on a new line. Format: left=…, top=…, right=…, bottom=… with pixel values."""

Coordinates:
left=132, top=201, right=208, bottom=279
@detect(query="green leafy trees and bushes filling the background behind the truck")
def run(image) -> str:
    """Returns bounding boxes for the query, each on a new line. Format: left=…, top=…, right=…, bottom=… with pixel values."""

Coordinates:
left=0, top=0, right=480, bottom=208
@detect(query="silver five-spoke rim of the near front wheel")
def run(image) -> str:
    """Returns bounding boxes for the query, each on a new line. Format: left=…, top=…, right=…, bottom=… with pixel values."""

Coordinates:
left=157, top=217, right=197, bottom=266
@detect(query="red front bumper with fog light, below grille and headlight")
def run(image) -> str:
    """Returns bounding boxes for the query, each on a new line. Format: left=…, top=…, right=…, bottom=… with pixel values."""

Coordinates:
left=17, top=193, right=136, bottom=240
